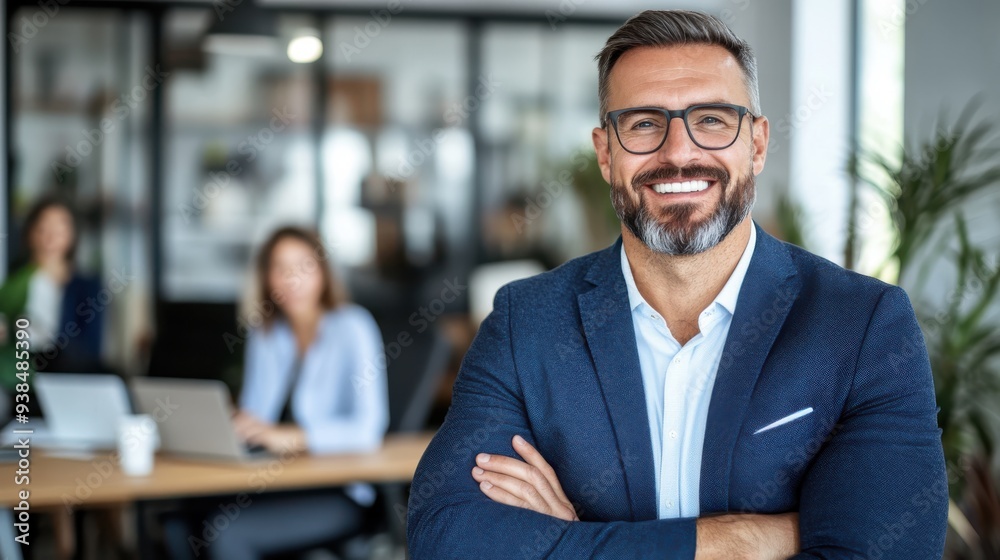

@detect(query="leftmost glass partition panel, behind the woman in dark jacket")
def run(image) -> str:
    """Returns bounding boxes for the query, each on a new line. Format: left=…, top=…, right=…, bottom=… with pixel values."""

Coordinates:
left=5, top=8, right=153, bottom=369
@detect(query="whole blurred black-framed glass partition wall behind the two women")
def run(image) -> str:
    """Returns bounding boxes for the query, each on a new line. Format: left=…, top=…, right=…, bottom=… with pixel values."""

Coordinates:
left=6, top=0, right=620, bottom=371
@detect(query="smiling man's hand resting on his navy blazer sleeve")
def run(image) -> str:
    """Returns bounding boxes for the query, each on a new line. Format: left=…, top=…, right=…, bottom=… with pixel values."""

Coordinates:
left=472, top=436, right=580, bottom=521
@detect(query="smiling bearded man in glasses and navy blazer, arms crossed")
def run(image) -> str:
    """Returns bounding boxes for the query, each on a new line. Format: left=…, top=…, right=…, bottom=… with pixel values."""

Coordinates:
left=408, top=11, right=948, bottom=560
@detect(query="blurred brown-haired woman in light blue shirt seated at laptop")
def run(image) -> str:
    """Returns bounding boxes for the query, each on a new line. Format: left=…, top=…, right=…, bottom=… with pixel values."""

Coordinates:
left=235, top=227, right=389, bottom=453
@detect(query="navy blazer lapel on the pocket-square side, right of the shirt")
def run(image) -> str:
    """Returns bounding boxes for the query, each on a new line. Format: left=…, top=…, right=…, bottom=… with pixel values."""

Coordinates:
left=700, top=224, right=800, bottom=513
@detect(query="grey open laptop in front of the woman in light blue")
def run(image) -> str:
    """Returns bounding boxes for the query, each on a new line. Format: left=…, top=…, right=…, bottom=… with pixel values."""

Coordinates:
left=130, top=377, right=271, bottom=461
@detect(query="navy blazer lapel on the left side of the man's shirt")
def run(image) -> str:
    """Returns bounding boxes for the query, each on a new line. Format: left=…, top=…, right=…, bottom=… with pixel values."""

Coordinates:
left=577, top=238, right=657, bottom=521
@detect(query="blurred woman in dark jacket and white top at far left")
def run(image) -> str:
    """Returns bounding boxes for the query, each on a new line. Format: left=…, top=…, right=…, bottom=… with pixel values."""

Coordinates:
left=0, top=197, right=107, bottom=389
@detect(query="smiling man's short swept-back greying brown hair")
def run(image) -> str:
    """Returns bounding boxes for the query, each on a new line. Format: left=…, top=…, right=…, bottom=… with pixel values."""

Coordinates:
left=596, top=10, right=761, bottom=126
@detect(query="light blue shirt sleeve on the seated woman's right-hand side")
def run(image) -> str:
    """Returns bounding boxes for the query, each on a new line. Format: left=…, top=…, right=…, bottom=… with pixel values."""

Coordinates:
left=302, top=307, right=389, bottom=454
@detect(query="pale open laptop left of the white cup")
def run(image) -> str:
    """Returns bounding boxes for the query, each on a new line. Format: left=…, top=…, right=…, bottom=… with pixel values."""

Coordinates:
left=33, top=373, right=132, bottom=451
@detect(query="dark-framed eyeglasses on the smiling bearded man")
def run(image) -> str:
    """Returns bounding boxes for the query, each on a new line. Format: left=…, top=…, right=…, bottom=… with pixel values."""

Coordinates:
left=605, top=103, right=757, bottom=155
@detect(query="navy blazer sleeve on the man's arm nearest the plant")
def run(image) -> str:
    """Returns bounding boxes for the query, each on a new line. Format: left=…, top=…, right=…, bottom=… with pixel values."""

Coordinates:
left=794, top=287, right=948, bottom=560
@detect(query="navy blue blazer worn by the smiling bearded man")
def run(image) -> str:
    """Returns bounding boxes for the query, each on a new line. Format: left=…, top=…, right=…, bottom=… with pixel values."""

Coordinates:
left=408, top=221, right=948, bottom=560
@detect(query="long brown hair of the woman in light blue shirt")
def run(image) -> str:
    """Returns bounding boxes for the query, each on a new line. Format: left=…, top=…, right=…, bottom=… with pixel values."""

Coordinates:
left=257, top=226, right=347, bottom=328
